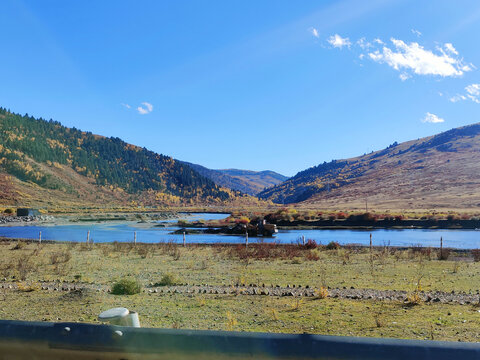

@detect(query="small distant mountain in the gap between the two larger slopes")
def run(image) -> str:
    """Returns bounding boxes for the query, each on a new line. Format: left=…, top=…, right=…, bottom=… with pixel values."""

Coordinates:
left=179, top=162, right=288, bottom=195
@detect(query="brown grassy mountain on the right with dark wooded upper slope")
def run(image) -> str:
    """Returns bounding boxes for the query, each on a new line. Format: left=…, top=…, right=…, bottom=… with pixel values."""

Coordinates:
left=258, top=123, right=480, bottom=210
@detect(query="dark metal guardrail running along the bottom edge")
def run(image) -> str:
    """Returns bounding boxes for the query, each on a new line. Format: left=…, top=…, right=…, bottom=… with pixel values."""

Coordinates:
left=0, top=320, right=480, bottom=360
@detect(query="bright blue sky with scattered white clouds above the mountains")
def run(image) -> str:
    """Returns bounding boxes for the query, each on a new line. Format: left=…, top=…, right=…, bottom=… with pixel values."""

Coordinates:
left=0, top=0, right=480, bottom=176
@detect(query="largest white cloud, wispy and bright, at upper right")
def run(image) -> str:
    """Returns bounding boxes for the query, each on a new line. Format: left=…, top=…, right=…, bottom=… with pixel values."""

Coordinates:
left=368, top=38, right=471, bottom=77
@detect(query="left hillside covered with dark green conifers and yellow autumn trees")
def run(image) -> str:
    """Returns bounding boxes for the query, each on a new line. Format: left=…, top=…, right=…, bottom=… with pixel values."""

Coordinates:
left=0, top=108, right=236, bottom=205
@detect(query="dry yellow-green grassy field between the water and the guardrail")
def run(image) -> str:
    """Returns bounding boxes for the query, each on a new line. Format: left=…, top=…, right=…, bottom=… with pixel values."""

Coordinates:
left=0, top=241, right=480, bottom=341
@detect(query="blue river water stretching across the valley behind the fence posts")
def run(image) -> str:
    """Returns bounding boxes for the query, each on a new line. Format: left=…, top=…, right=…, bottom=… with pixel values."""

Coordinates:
left=0, top=213, right=480, bottom=249
